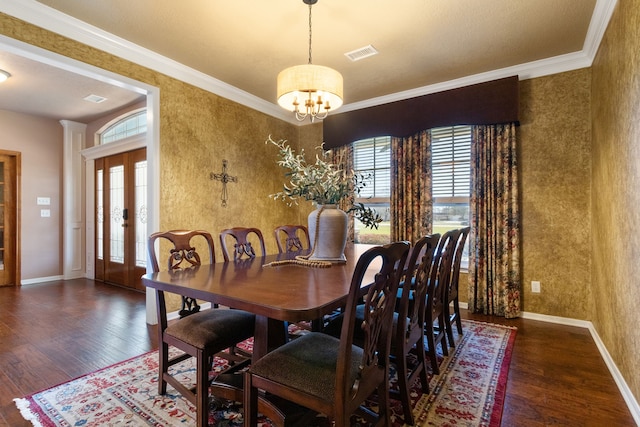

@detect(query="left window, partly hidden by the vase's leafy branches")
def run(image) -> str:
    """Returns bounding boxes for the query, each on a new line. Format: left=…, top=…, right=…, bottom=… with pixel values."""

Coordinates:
left=353, top=136, right=391, bottom=244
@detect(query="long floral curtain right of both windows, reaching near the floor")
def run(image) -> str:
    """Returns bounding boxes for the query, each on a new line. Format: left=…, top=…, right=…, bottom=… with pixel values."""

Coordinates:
left=469, top=123, right=521, bottom=318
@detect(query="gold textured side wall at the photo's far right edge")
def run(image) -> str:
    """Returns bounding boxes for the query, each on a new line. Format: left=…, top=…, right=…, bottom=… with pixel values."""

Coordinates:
left=591, top=0, right=640, bottom=401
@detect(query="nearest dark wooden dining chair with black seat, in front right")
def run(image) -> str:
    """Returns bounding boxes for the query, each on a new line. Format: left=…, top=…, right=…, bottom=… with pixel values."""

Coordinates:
left=244, top=242, right=409, bottom=427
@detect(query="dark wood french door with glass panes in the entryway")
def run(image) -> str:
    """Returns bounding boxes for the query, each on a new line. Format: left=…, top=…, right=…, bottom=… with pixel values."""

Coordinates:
left=95, top=148, right=147, bottom=290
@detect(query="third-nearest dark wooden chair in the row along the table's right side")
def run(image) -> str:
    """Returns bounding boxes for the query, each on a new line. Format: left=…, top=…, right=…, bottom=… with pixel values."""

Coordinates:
left=424, top=229, right=460, bottom=375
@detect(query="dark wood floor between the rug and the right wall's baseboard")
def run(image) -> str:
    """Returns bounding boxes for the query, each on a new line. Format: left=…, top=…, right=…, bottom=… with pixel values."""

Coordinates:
left=464, top=312, right=636, bottom=427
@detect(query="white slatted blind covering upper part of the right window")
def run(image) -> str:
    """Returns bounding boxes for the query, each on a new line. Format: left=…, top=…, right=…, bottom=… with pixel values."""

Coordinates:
left=431, top=126, right=471, bottom=198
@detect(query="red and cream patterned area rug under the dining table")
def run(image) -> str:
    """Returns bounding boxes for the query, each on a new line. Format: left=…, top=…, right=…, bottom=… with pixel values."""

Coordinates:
left=14, top=321, right=516, bottom=427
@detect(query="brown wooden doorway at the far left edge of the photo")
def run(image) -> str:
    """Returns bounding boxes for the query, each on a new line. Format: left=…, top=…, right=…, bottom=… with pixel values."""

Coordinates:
left=0, top=151, right=20, bottom=286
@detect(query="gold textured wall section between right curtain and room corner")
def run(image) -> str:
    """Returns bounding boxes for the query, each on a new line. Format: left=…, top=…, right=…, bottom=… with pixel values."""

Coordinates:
left=519, top=69, right=592, bottom=319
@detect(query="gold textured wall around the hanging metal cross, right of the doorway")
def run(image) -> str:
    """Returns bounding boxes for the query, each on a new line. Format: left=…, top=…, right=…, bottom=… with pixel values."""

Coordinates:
left=154, top=80, right=300, bottom=252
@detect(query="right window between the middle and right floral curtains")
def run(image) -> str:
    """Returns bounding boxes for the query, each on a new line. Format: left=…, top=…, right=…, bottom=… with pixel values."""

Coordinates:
left=431, top=126, right=471, bottom=268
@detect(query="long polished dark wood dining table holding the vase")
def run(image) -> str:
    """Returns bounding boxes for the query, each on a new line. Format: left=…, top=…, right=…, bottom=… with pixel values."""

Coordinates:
left=142, top=244, right=378, bottom=362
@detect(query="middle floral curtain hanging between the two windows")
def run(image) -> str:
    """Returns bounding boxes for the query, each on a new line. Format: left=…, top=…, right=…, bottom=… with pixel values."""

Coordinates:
left=390, top=131, right=433, bottom=242
